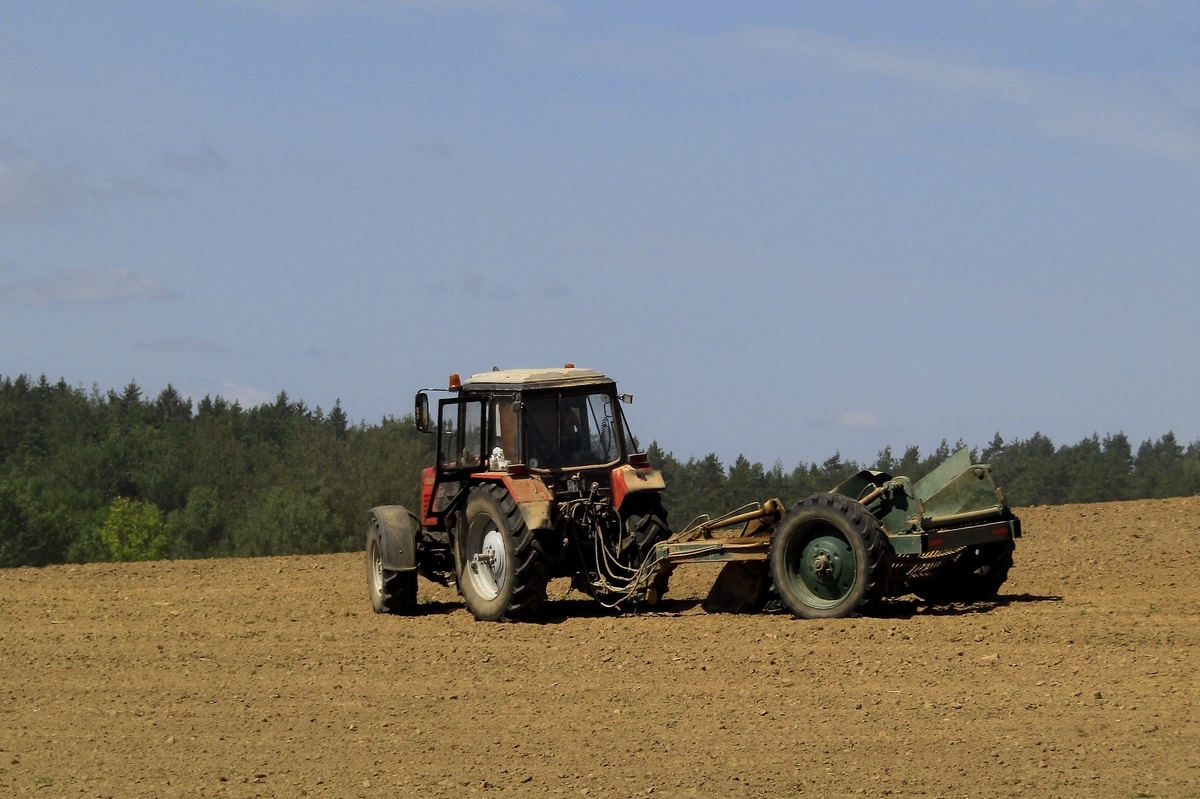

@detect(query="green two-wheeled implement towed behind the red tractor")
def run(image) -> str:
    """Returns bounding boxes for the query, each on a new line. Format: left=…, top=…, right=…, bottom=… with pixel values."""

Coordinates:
left=631, top=450, right=1021, bottom=618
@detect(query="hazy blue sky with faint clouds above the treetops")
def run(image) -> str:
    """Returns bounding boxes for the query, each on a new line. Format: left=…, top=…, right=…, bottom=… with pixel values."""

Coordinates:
left=0, top=0, right=1200, bottom=469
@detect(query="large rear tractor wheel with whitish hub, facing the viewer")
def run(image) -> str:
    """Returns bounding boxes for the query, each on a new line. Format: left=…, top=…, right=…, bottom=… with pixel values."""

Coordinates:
left=457, top=483, right=550, bottom=621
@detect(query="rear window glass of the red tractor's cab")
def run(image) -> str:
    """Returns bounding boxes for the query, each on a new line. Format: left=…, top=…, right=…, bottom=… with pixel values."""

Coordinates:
left=524, top=392, right=620, bottom=469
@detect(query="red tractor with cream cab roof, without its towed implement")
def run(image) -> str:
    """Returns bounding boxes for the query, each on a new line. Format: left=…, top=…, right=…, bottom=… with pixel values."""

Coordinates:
left=367, top=365, right=670, bottom=620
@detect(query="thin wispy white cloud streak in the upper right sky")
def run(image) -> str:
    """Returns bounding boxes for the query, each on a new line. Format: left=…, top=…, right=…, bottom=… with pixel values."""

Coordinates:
left=574, top=26, right=1200, bottom=166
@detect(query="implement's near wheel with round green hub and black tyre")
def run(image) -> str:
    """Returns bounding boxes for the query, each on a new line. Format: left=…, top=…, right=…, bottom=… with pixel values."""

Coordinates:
left=770, top=494, right=892, bottom=619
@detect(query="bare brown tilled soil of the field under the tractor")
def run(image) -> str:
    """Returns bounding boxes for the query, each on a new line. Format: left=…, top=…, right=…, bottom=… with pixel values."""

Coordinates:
left=0, top=497, right=1200, bottom=798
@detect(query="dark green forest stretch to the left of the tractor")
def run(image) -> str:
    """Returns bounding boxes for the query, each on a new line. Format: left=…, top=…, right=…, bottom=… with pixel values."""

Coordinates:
left=0, top=376, right=433, bottom=566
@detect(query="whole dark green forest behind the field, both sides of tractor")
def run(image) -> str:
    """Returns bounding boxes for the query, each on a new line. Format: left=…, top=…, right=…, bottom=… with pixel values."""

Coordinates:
left=0, top=376, right=1200, bottom=567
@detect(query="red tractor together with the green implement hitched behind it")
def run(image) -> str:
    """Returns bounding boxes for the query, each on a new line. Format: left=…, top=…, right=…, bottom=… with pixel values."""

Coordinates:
left=366, top=365, right=1021, bottom=620
